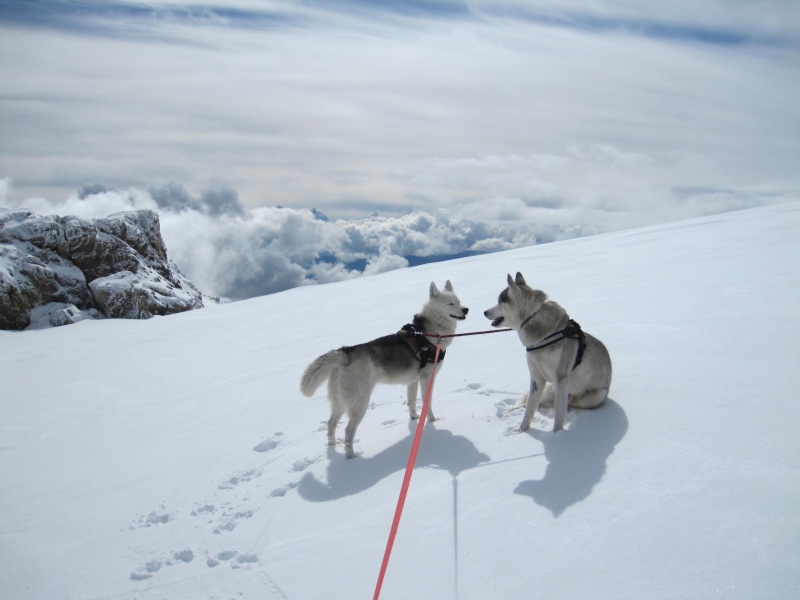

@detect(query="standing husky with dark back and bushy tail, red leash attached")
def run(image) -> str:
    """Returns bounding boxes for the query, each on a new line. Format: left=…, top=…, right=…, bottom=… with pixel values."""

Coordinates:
left=300, top=281, right=469, bottom=458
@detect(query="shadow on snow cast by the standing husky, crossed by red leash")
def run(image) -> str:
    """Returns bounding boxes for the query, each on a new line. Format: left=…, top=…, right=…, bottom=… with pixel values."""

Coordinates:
left=297, top=421, right=491, bottom=502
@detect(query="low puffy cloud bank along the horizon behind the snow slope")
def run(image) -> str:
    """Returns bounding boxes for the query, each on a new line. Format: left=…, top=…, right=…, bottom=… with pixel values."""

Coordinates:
left=0, top=146, right=800, bottom=300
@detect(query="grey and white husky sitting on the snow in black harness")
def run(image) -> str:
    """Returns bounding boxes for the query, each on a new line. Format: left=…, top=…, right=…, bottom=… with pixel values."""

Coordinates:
left=483, top=273, right=611, bottom=431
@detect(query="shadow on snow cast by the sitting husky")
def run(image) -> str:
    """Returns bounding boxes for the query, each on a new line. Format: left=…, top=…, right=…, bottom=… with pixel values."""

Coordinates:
left=514, top=398, right=628, bottom=518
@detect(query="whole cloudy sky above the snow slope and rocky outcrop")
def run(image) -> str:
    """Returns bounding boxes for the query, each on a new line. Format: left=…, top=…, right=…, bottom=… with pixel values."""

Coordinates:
left=0, top=0, right=800, bottom=298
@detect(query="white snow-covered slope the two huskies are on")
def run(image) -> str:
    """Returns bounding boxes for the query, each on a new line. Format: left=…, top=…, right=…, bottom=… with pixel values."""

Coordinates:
left=0, top=203, right=800, bottom=600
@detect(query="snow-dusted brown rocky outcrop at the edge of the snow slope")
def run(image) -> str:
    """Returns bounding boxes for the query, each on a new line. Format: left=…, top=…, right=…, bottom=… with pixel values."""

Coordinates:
left=0, top=209, right=203, bottom=329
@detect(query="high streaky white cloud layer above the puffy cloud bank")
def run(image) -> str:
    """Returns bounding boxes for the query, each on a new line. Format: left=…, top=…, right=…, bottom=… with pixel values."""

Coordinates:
left=0, top=0, right=800, bottom=218
